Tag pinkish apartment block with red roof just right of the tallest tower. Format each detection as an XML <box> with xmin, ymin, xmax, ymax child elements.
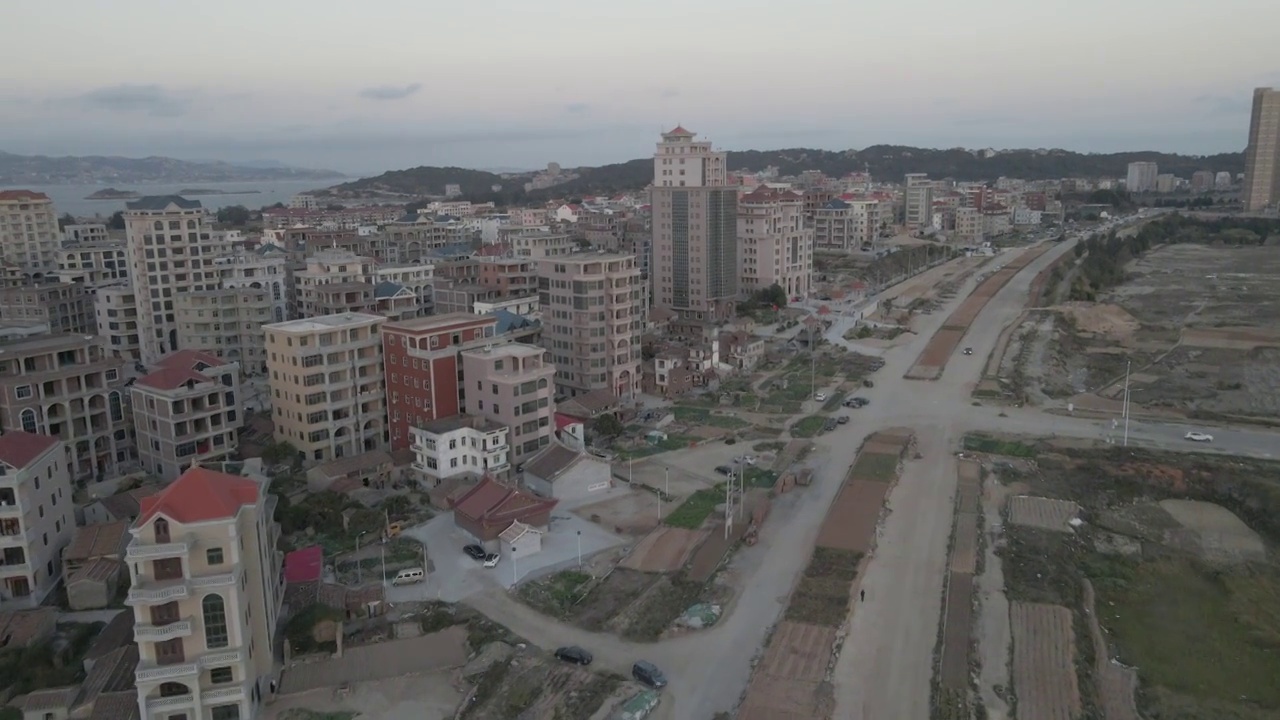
<box><xmin>737</xmin><ymin>187</ymin><xmax>813</xmax><ymax>297</ymax></box>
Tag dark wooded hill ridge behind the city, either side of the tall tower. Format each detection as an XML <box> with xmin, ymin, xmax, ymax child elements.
<box><xmin>330</xmin><ymin>145</ymin><xmax>1244</xmax><ymax>204</ymax></box>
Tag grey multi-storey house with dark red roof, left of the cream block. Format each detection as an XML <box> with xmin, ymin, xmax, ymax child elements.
<box><xmin>129</xmin><ymin>350</ymin><xmax>244</xmax><ymax>480</ymax></box>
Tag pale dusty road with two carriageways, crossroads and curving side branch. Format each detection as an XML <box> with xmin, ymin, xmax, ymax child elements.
<box><xmin>453</xmin><ymin>219</ymin><xmax>1280</xmax><ymax>720</ymax></box>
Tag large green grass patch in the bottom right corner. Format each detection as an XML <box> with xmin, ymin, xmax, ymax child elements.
<box><xmin>1097</xmin><ymin>559</ymin><xmax>1280</xmax><ymax>717</ymax></box>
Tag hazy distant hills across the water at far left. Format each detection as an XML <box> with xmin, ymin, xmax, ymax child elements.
<box><xmin>0</xmin><ymin>152</ymin><xmax>344</xmax><ymax>186</ymax></box>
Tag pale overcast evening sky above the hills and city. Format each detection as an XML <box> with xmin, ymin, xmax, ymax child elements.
<box><xmin>0</xmin><ymin>0</ymin><xmax>1280</xmax><ymax>174</ymax></box>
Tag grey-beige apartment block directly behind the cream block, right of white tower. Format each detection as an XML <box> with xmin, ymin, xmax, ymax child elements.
<box><xmin>174</xmin><ymin>287</ymin><xmax>277</xmax><ymax>375</ymax></box>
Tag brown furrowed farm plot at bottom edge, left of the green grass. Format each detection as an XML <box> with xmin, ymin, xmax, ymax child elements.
<box><xmin>1009</xmin><ymin>602</ymin><xmax>1080</xmax><ymax>720</ymax></box>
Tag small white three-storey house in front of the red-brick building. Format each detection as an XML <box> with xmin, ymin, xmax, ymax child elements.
<box><xmin>410</xmin><ymin>415</ymin><xmax>511</xmax><ymax>488</ymax></box>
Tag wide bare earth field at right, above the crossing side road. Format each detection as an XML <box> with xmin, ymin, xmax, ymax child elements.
<box><xmin>1001</xmin><ymin>243</ymin><xmax>1280</xmax><ymax>419</ymax></box>
